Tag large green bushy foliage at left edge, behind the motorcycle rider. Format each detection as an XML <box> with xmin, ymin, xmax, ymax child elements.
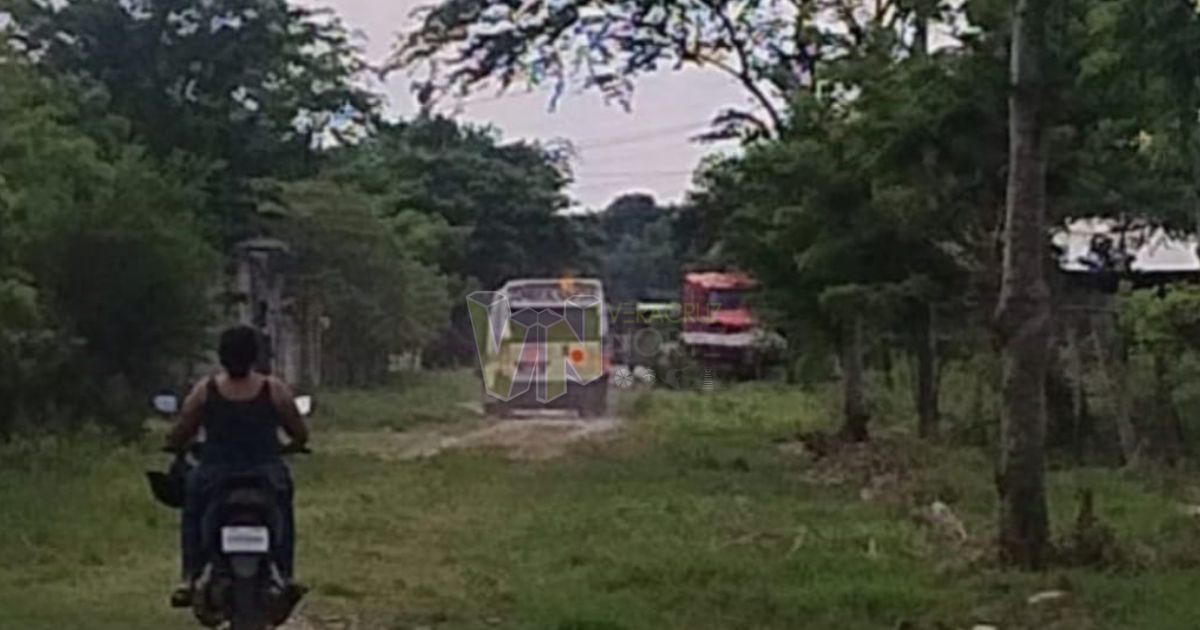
<box><xmin>0</xmin><ymin>54</ymin><xmax>214</xmax><ymax>432</ymax></box>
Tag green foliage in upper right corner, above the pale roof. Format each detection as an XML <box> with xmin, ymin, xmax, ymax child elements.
<box><xmin>1048</xmin><ymin>0</ymin><xmax>1200</xmax><ymax>228</ymax></box>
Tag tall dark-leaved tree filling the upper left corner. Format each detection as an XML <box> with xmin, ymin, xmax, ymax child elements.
<box><xmin>6</xmin><ymin>0</ymin><xmax>378</xmax><ymax>241</ymax></box>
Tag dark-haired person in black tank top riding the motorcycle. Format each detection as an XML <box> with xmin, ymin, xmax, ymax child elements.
<box><xmin>167</xmin><ymin>326</ymin><xmax>308</xmax><ymax>607</ymax></box>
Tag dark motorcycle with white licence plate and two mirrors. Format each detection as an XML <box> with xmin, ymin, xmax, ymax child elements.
<box><xmin>146</xmin><ymin>394</ymin><xmax>313</xmax><ymax>630</ymax></box>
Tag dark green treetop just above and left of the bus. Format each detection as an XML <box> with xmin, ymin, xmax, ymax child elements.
<box><xmin>332</xmin><ymin>118</ymin><xmax>577</xmax><ymax>289</ymax></box>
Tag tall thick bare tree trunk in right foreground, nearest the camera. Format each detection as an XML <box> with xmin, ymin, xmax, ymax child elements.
<box><xmin>996</xmin><ymin>0</ymin><xmax>1050</xmax><ymax>569</ymax></box>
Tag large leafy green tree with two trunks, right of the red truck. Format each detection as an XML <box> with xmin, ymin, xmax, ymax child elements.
<box><xmin>694</xmin><ymin>39</ymin><xmax>984</xmax><ymax>439</ymax></box>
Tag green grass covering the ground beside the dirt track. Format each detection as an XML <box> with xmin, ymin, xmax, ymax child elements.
<box><xmin>0</xmin><ymin>377</ymin><xmax>1200</xmax><ymax>630</ymax></box>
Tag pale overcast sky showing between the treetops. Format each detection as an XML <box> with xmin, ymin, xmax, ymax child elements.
<box><xmin>312</xmin><ymin>0</ymin><xmax>745</xmax><ymax>208</ymax></box>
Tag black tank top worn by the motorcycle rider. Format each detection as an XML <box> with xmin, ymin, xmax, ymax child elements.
<box><xmin>200</xmin><ymin>378</ymin><xmax>283</xmax><ymax>467</ymax></box>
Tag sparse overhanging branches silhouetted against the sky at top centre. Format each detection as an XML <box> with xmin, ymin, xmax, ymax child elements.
<box><xmin>394</xmin><ymin>0</ymin><xmax>950</xmax><ymax>137</ymax></box>
